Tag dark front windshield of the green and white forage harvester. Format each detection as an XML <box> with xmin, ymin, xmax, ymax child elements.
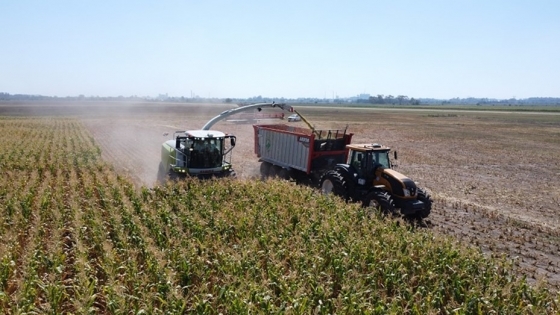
<box><xmin>187</xmin><ymin>138</ymin><xmax>224</xmax><ymax>168</ymax></box>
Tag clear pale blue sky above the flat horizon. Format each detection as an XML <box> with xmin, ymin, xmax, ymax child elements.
<box><xmin>0</xmin><ymin>0</ymin><xmax>560</xmax><ymax>98</ymax></box>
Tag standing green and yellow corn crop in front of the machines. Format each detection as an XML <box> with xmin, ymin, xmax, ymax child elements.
<box><xmin>0</xmin><ymin>117</ymin><xmax>559</xmax><ymax>314</ymax></box>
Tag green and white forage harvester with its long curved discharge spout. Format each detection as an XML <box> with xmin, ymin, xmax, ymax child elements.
<box><xmin>158</xmin><ymin>102</ymin><xmax>293</xmax><ymax>182</ymax></box>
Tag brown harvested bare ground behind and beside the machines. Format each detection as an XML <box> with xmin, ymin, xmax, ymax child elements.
<box><xmin>0</xmin><ymin>103</ymin><xmax>560</xmax><ymax>291</ymax></box>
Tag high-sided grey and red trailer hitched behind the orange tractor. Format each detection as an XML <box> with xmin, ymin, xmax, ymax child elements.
<box><xmin>253</xmin><ymin>124</ymin><xmax>353</xmax><ymax>183</ymax></box>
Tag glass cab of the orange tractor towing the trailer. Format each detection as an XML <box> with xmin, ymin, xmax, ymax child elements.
<box><xmin>346</xmin><ymin>143</ymin><xmax>396</xmax><ymax>185</ymax></box>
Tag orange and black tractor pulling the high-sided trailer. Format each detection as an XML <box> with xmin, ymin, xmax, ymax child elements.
<box><xmin>320</xmin><ymin>143</ymin><xmax>432</xmax><ymax>219</ymax></box>
